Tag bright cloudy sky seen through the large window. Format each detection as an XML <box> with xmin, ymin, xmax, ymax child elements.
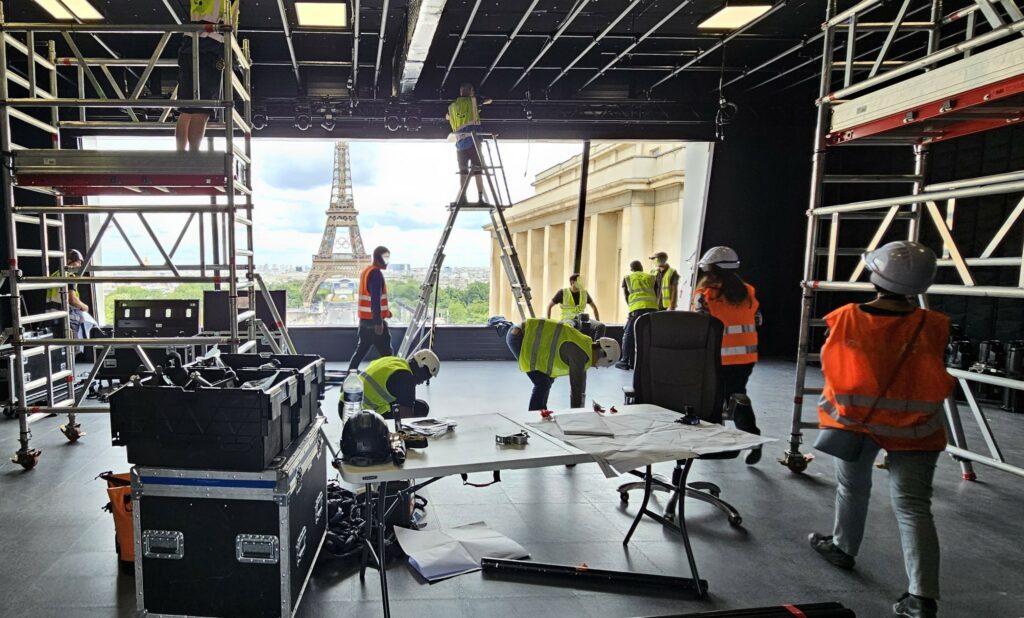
<box><xmin>86</xmin><ymin>138</ymin><xmax>582</xmax><ymax>266</ymax></box>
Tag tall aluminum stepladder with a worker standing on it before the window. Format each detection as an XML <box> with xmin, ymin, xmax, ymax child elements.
<box><xmin>398</xmin><ymin>133</ymin><xmax>535</xmax><ymax>358</ymax></box>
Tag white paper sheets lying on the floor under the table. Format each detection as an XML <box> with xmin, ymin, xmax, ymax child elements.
<box><xmin>394</xmin><ymin>522</ymin><xmax>529</xmax><ymax>581</ymax></box>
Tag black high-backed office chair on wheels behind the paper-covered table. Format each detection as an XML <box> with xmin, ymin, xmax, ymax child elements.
<box><xmin>618</xmin><ymin>311</ymin><xmax>743</xmax><ymax>527</ymax></box>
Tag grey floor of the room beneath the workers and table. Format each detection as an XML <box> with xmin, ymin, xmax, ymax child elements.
<box><xmin>0</xmin><ymin>362</ymin><xmax>1024</xmax><ymax>618</ymax></box>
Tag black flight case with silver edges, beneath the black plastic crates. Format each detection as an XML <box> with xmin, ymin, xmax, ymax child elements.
<box><xmin>131</xmin><ymin>420</ymin><xmax>327</xmax><ymax>618</ymax></box>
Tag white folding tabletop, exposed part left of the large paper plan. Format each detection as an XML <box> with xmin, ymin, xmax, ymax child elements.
<box><xmin>341</xmin><ymin>412</ymin><xmax>593</xmax><ymax>483</ymax></box>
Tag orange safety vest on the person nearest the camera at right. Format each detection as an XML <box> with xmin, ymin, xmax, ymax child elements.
<box><xmin>818</xmin><ymin>304</ymin><xmax>953</xmax><ymax>451</ymax></box>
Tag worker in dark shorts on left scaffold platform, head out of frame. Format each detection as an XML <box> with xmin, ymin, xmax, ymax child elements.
<box><xmin>174</xmin><ymin>0</ymin><xmax>239</xmax><ymax>152</ymax></box>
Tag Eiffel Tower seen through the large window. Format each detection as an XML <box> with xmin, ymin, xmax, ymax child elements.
<box><xmin>302</xmin><ymin>141</ymin><xmax>370</xmax><ymax>305</ymax></box>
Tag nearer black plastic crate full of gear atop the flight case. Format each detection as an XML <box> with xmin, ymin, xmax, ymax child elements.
<box><xmin>111</xmin><ymin>369</ymin><xmax>299</xmax><ymax>471</ymax></box>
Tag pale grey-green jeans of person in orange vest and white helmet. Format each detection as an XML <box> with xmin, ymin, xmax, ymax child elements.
<box><xmin>833</xmin><ymin>440</ymin><xmax>939</xmax><ymax>600</ymax></box>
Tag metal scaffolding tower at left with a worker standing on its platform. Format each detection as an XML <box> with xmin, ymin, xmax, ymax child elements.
<box><xmin>0</xmin><ymin>12</ymin><xmax>294</xmax><ymax>469</ymax></box>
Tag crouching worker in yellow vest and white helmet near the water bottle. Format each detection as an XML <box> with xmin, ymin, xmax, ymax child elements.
<box><xmin>354</xmin><ymin>350</ymin><xmax>441</xmax><ymax>418</ymax></box>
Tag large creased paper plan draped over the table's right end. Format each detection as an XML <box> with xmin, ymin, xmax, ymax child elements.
<box><xmin>527</xmin><ymin>410</ymin><xmax>774</xmax><ymax>479</ymax></box>
